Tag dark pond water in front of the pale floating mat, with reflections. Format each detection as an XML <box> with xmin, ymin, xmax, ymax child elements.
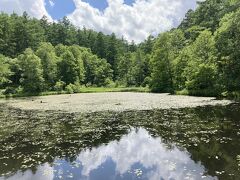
<box><xmin>0</xmin><ymin>104</ymin><xmax>240</xmax><ymax>180</ymax></box>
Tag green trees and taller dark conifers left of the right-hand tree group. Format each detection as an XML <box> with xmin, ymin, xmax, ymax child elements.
<box><xmin>0</xmin><ymin>13</ymin><xmax>150</xmax><ymax>94</ymax></box>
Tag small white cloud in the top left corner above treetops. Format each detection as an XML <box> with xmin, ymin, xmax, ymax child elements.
<box><xmin>0</xmin><ymin>0</ymin><xmax>52</xmax><ymax>20</ymax></box>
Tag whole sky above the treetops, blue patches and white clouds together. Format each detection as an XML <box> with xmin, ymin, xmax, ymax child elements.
<box><xmin>0</xmin><ymin>0</ymin><xmax>197</xmax><ymax>43</ymax></box>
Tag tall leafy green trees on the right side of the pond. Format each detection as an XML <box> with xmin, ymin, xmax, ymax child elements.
<box><xmin>150</xmin><ymin>0</ymin><xmax>240</xmax><ymax>95</ymax></box>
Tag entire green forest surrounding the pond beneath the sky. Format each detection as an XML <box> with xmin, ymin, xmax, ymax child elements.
<box><xmin>0</xmin><ymin>0</ymin><xmax>240</xmax><ymax>96</ymax></box>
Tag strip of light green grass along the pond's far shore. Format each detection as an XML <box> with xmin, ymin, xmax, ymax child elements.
<box><xmin>0</xmin><ymin>87</ymin><xmax>150</xmax><ymax>98</ymax></box>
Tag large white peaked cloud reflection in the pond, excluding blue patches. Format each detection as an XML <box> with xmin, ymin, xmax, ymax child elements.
<box><xmin>78</xmin><ymin>128</ymin><xmax>216</xmax><ymax>180</ymax></box>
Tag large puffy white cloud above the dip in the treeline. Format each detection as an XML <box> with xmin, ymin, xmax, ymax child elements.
<box><xmin>68</xmin><ymin>0</ymin><xmax>199</xmax><ymax>42</ymax></box>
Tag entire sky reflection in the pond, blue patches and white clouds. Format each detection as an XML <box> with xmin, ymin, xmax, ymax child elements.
<box><xmin>0</xmin><ymin>128</ymin><xmax>217</xmax><ymax>180</ymax></box>
